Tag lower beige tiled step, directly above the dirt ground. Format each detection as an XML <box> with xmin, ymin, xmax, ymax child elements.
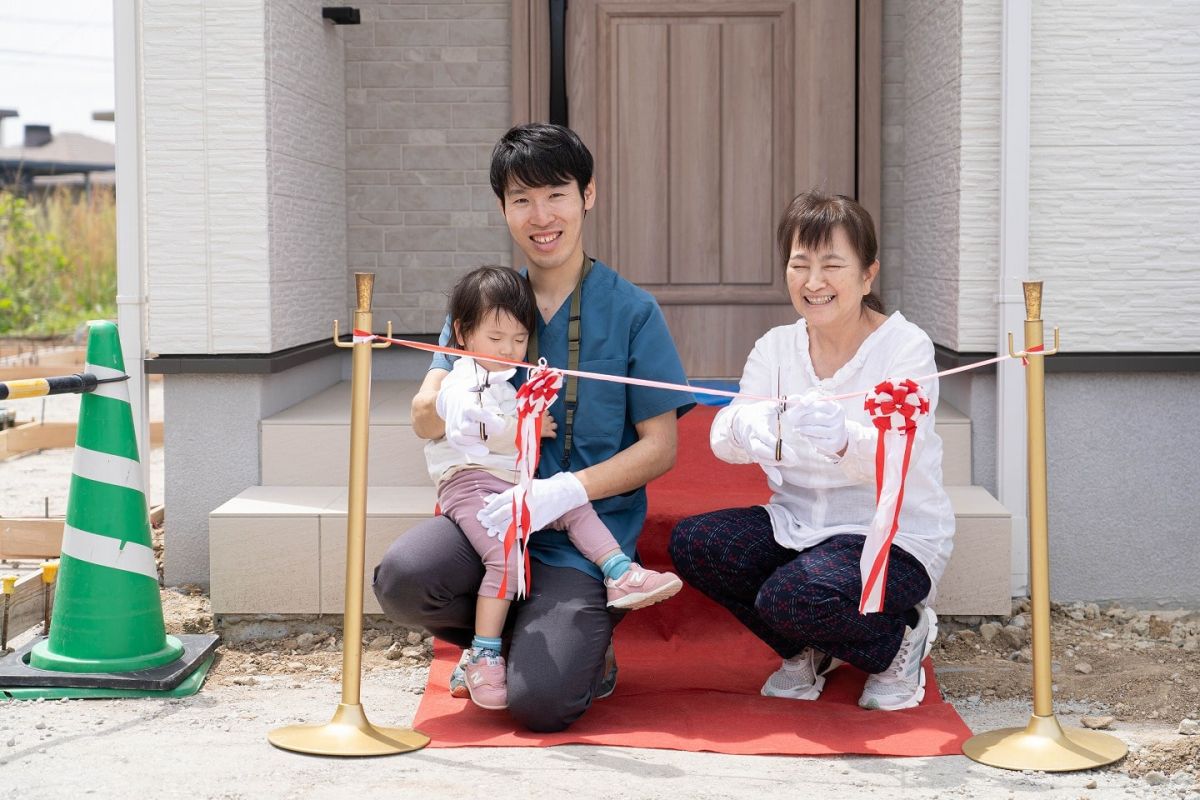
<box><xmin>209</xmin><ymin>486</ymin><xmax>1012</xmax><ymax>614</ymax></box>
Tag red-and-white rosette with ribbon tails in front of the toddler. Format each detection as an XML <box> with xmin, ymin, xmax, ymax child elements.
<box><xmin>496</xmin><ymin>359</ymin><xmax>563</xmax><ymax>599</ymax></box>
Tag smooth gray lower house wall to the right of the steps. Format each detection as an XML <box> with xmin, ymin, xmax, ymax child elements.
<box><xmin>942</xmin><ymin>365</ymin><xmax>1200</xmax><ymax>606</ymax></box>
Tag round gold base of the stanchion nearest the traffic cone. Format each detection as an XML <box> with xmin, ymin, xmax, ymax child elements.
<box><xmin>266</xmin><ymin>703</ymin><xmax>430</xmax><ymax>756</ymax></box>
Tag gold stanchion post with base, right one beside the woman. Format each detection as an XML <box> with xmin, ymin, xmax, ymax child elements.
<box><xmin>962</xmin><ymin>281</ymin><xmax>1128</xmax><ymax>772</ymax></box>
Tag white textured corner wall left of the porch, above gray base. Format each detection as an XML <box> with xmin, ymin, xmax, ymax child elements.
<box><xmin>142</xmin><ymin>0</ymin><xmax>346</xmax><ymax>354</ymax></box>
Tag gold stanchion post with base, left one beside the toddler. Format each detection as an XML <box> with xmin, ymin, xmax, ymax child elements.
<box><xmin>266</xmin><ymin>272</ymin><xmax>430</xmax><ymax>756</ymax></box>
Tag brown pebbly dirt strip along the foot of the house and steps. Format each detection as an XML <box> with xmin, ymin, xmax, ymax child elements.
<box><xmin>154</xmin><ymin>587</ymin><xmax>1200</xmax><ymax>781</ymax></box>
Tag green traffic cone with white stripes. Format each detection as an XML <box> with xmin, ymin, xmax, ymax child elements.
<box><xmin>29</xmin><ymin>321</ymin><xmax>184</xmax><ymax>673</ymax></box>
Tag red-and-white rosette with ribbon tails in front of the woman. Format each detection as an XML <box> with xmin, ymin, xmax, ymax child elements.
<box><xmin>858</xmin><ymin>379</ymin><xmax>929</xmax><ymax>614</ymax></box>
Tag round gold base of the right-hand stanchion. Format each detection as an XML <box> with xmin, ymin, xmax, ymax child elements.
<box><xmin>962</xmin><ymin>715</ymin><xmax>1129</xmax><ymax>772</ymax></box>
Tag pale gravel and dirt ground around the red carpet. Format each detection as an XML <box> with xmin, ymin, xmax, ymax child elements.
<box><xmin>0</xmin><ymin>383</ymin><xmax>1200</xmax><ymax>800</ymax></box>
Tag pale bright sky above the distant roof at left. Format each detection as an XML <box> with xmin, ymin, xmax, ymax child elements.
<box><xmin>0</xmin><ymin>0</ymin><xmax>116</xmax><ymax>146</ymax></box>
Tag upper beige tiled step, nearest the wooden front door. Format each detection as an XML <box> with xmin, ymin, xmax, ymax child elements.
<box><xmin>260</xmin><ymin>380</ymin><xmax>971</xmax><ymax>486</ymax></box>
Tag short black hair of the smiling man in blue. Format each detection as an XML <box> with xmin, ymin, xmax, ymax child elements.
<box><xmin>491</xmin><ymin>122</ymin><xmax>593</xmax><ymax>203</ymax></box>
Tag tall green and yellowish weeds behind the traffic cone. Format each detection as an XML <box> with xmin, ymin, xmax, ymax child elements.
<box><xmin>0</xmin><ymin>190</ymin><xmax>116</xmax><ymax>335</ymax></box>
